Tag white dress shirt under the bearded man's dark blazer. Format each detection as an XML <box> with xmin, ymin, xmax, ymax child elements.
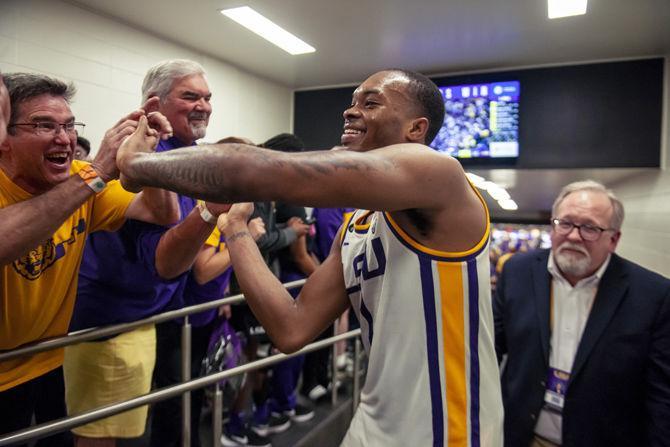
<box><xmin>535</xmin><ymin>252</ymin><xmax>610</xmax><ymax>445</ymax></box>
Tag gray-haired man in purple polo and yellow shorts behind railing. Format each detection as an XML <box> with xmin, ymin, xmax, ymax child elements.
<box><xmin>64</xmin><ymin>60</ymin><xmax>226</xmax><ymax>447</ymax></box>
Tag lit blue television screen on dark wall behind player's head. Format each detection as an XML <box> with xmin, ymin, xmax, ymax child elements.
<box><xmin>430</xmin><ymin>81</ymin><xmax>520</xmax><ymax>163</ymax></box>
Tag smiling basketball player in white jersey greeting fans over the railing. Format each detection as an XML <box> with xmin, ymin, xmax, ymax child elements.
<box><xmin>117</xmin><ymin>70</ymin><xmax>502</xmax><ymax>447</ymax></box>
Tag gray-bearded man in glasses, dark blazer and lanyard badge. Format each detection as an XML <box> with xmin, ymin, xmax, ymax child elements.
<box><xmin>493</xmin><ymin>180</ymin><xmax>670</xmax><ymax>447</ymax></box>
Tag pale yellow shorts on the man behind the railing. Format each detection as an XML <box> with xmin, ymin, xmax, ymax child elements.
<box><xmin>63</xmin><ymin>325</ymin><xmax>156</xmax><ymax>438</ymax></box>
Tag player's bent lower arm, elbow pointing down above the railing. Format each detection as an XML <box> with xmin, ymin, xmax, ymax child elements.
<box><xmin>220</xmin><ymin>203</ymin><xmax>349</xmax><ymax>353</ymax></box>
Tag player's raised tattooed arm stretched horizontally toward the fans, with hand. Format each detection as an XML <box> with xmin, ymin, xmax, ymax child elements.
<box><xmin>117</xmin><ymin>126</ymin><xmax>467</xmax><ymax>211</ymax></box>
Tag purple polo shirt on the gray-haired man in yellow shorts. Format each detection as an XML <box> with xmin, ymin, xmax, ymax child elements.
<box><xmin>70</xmin><ymin>137</ymin><xmax>196</xmax><ymax>331</ymax></box>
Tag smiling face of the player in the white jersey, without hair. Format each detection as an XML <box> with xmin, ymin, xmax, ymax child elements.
<box><xmin>340</xmin><ymin>71</ymin><xmax>415</xmax><ymax>151</ymax></box>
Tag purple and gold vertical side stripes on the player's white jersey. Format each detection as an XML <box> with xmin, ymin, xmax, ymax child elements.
<box><xmin>419</xmin><ymin>256</ymin><xmax>480</xmax><ymax>447</ymax></box>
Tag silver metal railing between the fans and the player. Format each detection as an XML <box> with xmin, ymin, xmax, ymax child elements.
<box><xmin>0</xmin><ymin>279</ymin><xmax>361</xmax><ymax>447</ymax></box>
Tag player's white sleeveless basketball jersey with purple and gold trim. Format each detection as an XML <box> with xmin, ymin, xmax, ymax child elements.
<box><xmin>342</xmin><ymin>210</ymin><xmax>503</xmax><ymax>447</ymax></box>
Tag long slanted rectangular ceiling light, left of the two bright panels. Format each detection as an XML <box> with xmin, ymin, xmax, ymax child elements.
<box><xmin>221</xmin><ymin>6</ymin><xmax>316</xmax><ymax>55</ymax></box>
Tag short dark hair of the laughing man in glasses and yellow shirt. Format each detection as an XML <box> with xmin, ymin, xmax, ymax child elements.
<box><xmin>2</xmin><ymin>73</ymin><xmax>77</xmax><ymax>126</ymax></box>
